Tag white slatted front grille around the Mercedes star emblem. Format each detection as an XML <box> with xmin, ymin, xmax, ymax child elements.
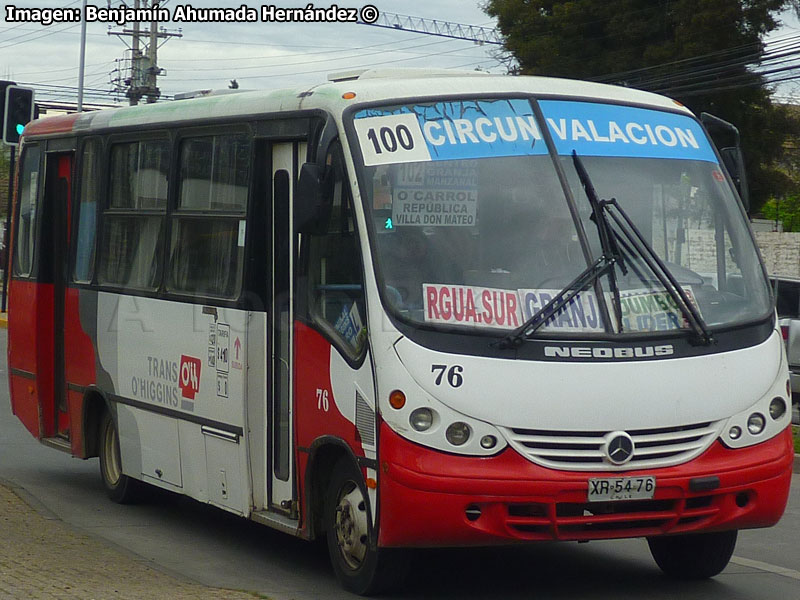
<box><xmin>503</xmin><ymin>421</ymin><xmax>723</xmax><ymax>471</ymax></box>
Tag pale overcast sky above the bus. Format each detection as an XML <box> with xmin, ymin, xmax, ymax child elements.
<box><xmin>0</xmin><ymin>0</ymin><xmax>800</xmax><ymax>102</ymax></box>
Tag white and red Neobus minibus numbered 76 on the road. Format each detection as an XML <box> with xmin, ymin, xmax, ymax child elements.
<box><xmin>8</xmin><ymin>71</ymin><xmax>792</xmax><ymax>593</ymax></box>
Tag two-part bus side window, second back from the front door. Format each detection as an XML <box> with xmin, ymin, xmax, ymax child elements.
<box><xmin>98</xmin><ymin>140</ymin><xmax>169</xmax><ymax>289</ymax></box>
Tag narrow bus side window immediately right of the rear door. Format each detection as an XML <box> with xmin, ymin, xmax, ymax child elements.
<box><xmin>72</xmin><ymin>139</ymin><xmax>102</xmax><ymax>283</ymax></box>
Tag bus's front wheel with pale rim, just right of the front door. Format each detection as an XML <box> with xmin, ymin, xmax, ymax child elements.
<box><xmin>325</xmin><ymin>458</ymin><xmax>408</xmax><ymax>596</ymax></box>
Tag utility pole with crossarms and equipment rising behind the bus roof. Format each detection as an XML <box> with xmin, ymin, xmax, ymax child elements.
<box><xmin>108</xmin><ymin>0</ymin><xmax>183</xmax><ymax>106</ymax></box>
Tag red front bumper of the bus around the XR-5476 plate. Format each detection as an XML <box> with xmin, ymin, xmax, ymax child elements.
<box><xmin>378</xmin><ymin>423</ymin><xmax>794</xmax><ymax>547</ymax></box>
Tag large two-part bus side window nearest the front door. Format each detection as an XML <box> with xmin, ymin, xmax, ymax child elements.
<box><xmin>167</xmin><ymin>134</ymin><xmax>250</xmax><ymax>298</ymax></box>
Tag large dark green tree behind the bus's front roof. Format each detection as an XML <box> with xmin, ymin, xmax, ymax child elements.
<box><xmin>484</xmin><ymin>0</ymin><xmax>800</xmax><ymax>211</ymax></box>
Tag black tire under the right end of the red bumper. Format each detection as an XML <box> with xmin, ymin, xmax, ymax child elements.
<box><xmin>647</xmin><ymin>529</ymin><xmax>738</xmax><ymax>579</ymax></box>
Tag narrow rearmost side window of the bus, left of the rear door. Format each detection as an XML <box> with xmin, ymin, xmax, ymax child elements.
<box><xmin>14</xmin><ymin>146</ymin><xmax>41</xmax><ymax>277</ymax></box>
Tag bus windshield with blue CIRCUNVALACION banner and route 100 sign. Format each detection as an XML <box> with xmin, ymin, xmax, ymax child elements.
<box><xmin>353</xmin><ymin>99</ymin><xmax>770</xmax><ymax>335</ymax></box>
